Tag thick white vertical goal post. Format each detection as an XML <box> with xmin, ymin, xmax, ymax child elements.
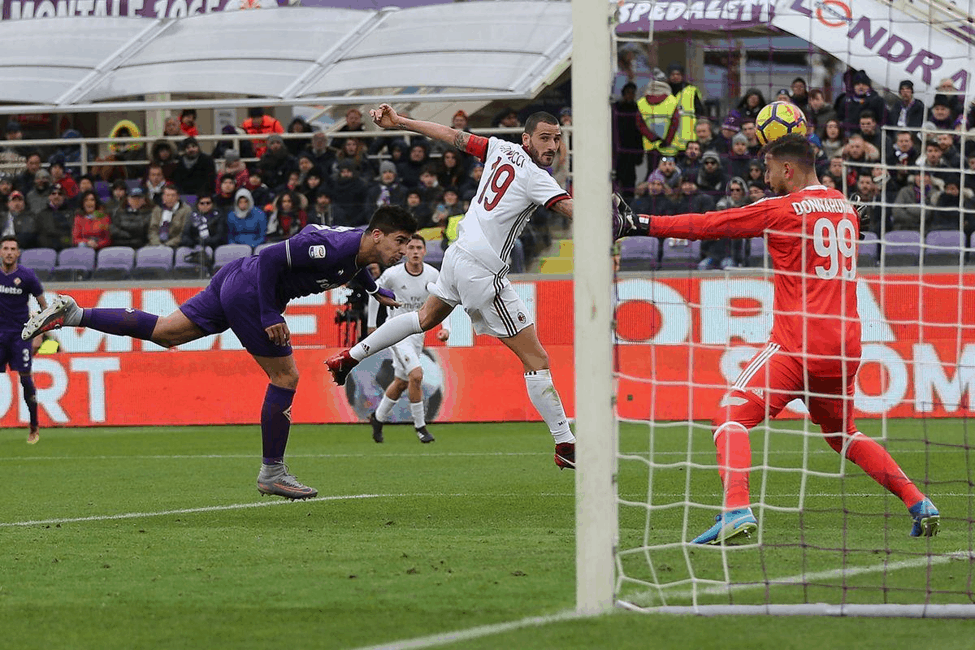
<box><xmin>572</xmin><ymin>0</ymin><xmax>619</xmax><ymax>614</ymax></box>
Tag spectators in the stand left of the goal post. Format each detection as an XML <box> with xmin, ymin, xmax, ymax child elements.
<box><xmin>0</xmin><ymin>108</ymin><xmax>570</xmax><ymax>272</ymax></box>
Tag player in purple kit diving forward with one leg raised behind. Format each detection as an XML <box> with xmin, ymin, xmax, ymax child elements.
<box><xmin>21</xmin><ymin>206</ymin><xmax>416</xmax><ymax>499</ymax></box>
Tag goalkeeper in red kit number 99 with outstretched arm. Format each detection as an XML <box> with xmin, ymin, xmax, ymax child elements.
<box><xmin>614</xmin><ymin>134</ymin><xmax>939</xmax><ymax>544</ymax></box>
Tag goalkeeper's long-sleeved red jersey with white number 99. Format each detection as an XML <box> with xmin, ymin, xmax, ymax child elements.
<box><xmin>649</xmin><ymin>185</ymin><xmax>860</xmax><ymax>377</ymax></box>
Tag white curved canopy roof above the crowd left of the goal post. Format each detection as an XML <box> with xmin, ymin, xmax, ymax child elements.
<box><xmin>0</xmin><ymin>1</ymin><xmax>572</xmax><ymax>114</ymax></box>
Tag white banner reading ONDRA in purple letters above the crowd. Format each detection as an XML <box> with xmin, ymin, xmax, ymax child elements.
<box><xmin>771</xmin><ymin>0</ymin><xmax>975</xmax><ymax>94</ymax></box>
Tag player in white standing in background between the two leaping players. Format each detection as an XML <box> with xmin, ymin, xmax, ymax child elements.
<box><xmin>368</xmin><ymin>235</ymin><xmax>450</xmax><ymax>442</ymax></box>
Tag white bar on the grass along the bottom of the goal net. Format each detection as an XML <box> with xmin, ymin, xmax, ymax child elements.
<box><xmin>617</xmin><ymin>601</ymin><xmax>975</xmax><ymax>618</ymax></box>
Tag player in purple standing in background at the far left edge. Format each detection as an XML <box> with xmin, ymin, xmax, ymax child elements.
<box><xmin>0</xmin><ymin>235</ymin><xmax>47</xmax><ymax>445</ymax></box>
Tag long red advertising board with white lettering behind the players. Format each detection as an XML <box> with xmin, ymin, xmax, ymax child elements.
<box><xmin>0</xmin><ymin>274</ymin><xmax>975</xmax><ymax>427</ymax></box>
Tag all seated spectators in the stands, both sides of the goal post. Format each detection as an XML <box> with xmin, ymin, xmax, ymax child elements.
<box><xmin>0</xmin><ymin>63</ymin><xmax>975</xmax><ymax>272</ymax></box>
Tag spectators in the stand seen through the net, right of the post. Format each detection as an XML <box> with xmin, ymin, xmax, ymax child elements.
<box><xmin>613</xmin><ymin>64</ymin><xmax>975</xmax><ymax>269</ymax></box>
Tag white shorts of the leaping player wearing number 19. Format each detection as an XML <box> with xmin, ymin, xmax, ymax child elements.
<box><xmin>430</xmin><ymin>246</ymin><xmax>534</xmax><ymax>338</ymax></box>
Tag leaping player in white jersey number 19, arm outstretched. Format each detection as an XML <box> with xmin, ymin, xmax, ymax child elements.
<box><xmin>326</xmin><ymin>104</ymin><xmax>575</xmax><ymax>469</ymax></box>
